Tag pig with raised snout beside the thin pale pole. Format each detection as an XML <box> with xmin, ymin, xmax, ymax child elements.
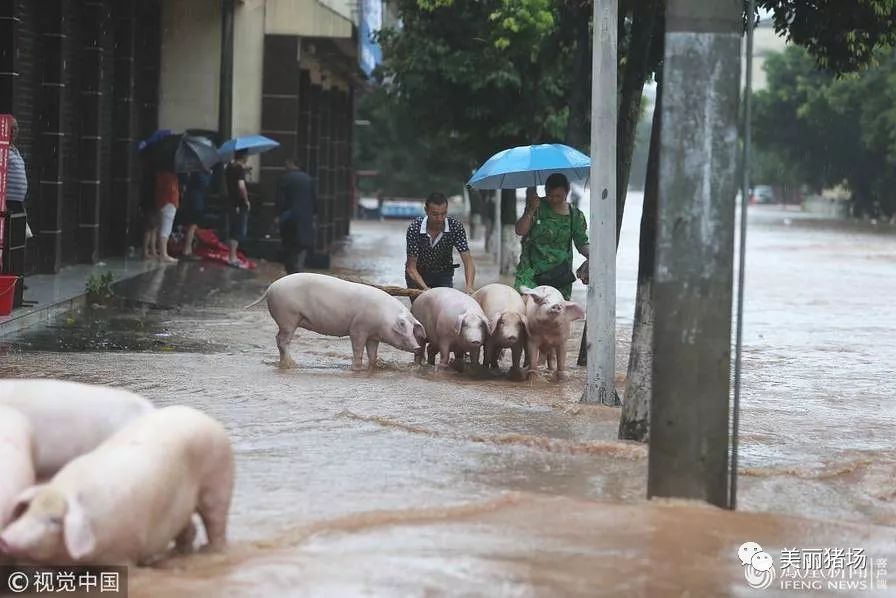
<box><xmin>520</xmin><ymin>286</ymin><xmax>585</xmax><ymax>379</ymax></box>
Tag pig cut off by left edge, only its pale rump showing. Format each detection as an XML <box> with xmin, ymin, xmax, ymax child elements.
<box><xmin>0</xmin><ymin>406</ymin><xmax>36</xmax><ymax>532</ymax></box>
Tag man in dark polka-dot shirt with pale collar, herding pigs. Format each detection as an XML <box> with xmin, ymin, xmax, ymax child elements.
<box><xmin>405</xmin><ymin>193</ymin><xmax>476</xmax><ymax>293</ymax></box>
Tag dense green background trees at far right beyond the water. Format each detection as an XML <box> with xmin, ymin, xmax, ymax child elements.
<box><xmin>753</xmin><ymin>46</ymin><xmax>896</xmax><ymax>214</ymax></box>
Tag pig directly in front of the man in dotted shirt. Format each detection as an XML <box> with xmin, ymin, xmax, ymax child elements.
<box><xmin>411</xmin><ymin>287</ymin><xmax>489</xmax><ymax>371</ymax></box>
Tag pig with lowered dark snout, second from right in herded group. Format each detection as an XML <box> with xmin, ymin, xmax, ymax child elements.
<box><xmin>473</xmin><ymin>283</ymin><xmax>526</xmax><ymax>373</ymax></box>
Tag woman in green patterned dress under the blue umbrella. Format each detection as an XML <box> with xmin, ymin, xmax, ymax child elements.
<box><xmin>513</xmin><ymin>173</ymin><xmax>588</xmax><ymax>301</ymax></box>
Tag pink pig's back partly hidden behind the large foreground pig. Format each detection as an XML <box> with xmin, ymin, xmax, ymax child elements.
<box><xmin>0</xmin><ymin>379</ymin><xmax>154</xmax><ymax>479</ymax></box>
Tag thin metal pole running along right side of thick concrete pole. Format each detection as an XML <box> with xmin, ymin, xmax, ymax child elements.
<box><xmin>728</xmin><ymin>0</ymin><xmax>756</xmax><ymax>509</ymax></box>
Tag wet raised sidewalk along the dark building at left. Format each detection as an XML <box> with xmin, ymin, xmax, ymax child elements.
<box><xmin>0</xmin><ymin>258</ymin><xmax>165</xmax><ymax>337</ymax></box>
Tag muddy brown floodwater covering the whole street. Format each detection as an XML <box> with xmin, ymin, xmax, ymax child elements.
<box><xmin>0</xmin><ymin>194</ymin><xmax>896</xmax><ymax>596</ymax></box>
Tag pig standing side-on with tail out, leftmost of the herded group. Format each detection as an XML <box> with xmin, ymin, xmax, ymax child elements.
<box><xmin>246</xmin><ymin>273</ymin><xmax>426</xmax><ymax>370</ymax></box>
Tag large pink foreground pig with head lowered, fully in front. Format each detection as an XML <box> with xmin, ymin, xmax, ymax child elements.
<box><xmin>0</xmin><ymin>406</ymin><xmax>233</xmax><ymax>565</ymax></box>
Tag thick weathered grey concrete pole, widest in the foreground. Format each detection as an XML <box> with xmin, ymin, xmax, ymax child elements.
<box><xmin>647</xmin><ymin>0</ymin><xmax>743</xmax><ymax>507</ymax></box>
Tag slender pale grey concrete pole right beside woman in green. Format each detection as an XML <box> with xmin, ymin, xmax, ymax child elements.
<box><xmin>582</xmin><ymin>0</ymin><xmax>619</xmax><ymax>405</ymax></box>
